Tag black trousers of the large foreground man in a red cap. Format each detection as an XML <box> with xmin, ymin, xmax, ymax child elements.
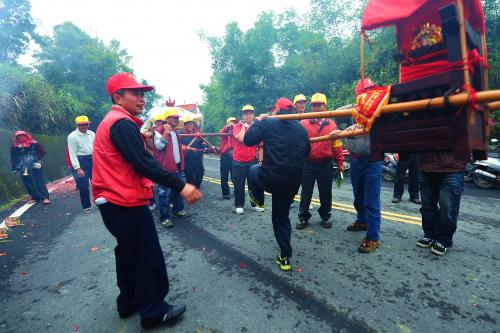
<box><xmin>98</xmin><ymin>202</ymin><xmax>169</xmax><ymax>318</ymax></box>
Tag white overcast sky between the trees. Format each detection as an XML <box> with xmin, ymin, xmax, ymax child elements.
<box><xmin>31</xmin><ymin>0</ymin><xmax>310</xmax><ymax>104</ymax></box>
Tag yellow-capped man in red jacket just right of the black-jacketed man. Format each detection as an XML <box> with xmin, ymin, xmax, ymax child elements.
<box><xmin>296</xmin><ymin>93</ymin><xmax>344</xmax><ymax>229</ymax></box>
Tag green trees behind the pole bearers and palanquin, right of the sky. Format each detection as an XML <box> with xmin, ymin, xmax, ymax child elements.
<box><xmin>200</xmin><ymin>0</ymin><xmax>500</xmax><ymax>137</ymax></box>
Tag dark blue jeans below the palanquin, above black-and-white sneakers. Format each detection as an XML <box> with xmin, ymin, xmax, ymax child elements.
<box><xmin>418</xmin><ymin>172</ymin><xmax>464</xmax><ymax>247</ymax></box>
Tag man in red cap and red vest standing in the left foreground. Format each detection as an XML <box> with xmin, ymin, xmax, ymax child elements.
<box><xmin>92</xmin><ymin>73</ymin><xmax>202</xmax><ymax>328</ymax></box>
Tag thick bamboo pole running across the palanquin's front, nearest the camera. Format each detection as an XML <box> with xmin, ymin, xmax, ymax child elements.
<box><xmin>269</xmin><ymin>89</ymin><xmax>500</xmax><ymax>120</ymax></box>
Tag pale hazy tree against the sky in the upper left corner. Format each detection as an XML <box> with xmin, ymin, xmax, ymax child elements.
<box><xmin>0</xmin><ymin>0</ymin><xmax>38</xmax><ymax>63</ymax></box>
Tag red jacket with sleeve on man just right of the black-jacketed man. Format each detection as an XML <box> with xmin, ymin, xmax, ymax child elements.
<box><xmin>300</xmin><ymin>118</ymin><xmax>344</xmax><ymax>168</ymax></box>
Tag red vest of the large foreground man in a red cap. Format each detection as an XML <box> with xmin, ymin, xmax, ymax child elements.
<box><xmin>92</xmin><ymin>105</ymin><xmax>153</xmax><ymax>207</ymax></box>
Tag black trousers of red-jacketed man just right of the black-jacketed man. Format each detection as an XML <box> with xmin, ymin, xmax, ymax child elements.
<box><xmin>299</xmin><ymin>159</ymin><xmax>333</xmax><ymax>221</ymax></box>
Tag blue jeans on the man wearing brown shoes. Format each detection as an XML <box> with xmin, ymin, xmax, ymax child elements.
<box><xmin>349</xmin><ymin>157</ymin><xmax>382</xmax><ymax>240</ymax></box>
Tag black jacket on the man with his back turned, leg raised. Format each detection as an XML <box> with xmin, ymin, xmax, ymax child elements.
<box><xmin>243</xmin><ymin>118</ymin><xmax>311</xmax><ymax>193</ymax></box>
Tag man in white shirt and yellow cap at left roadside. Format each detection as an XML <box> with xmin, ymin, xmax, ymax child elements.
<box><xmin>68</xmin><ymin>116</ymin><xmax>95</xmax><ymax>212</ymax></box>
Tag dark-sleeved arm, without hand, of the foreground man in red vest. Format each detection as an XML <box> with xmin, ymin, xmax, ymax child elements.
<box><xmin>110</xmin><ymin>119</ymin><xmax>185</xmax><ymax>192</ymax></box>
